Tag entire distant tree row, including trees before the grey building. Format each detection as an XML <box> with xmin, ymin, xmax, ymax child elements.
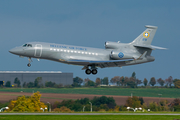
<box><xmin>2</xmin><ymin>72</ymin><xmax>180</xmax><ymax>88</ymax></box>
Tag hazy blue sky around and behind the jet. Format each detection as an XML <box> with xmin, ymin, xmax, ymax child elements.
<box><xmin>0</xmin><ymin>0</ymin><xmax>180</xmax><ymax>80</ymax></box>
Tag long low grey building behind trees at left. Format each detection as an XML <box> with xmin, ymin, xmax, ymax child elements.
<box><xmin>0</xmin><ymin>71</ymin><xmax>73</xmax><ymax>86</ymax></box>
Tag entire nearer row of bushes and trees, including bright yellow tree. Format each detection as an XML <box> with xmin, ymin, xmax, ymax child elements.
<box><xmin>0</xmin><ymin>92</ymin><xmax>180</xmax><ymax>112</ymax></box>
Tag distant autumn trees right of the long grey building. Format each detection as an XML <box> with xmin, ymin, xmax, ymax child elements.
<box><xmin>72</xmin><ymin>72</ymin><xmax>180</xmax><ymax>88</ymax></box>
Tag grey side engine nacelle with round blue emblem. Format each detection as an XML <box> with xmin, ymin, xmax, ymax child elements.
<box><xmin>110</xmin><ymin>50</ymin><xmax>134</xmax><ymax>60</ymax></box>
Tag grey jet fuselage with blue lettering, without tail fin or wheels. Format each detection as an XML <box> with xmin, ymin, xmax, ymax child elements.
<box><xmin>9</xmin><ymin>42</ymin><xmax>155</xmax><ymax>68</ymax></box>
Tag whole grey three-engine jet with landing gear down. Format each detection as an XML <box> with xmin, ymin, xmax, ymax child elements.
<box><xmin>9</xmin><ymin>25</ymin><xmax>166</xmax><ymax>74</ymax></box>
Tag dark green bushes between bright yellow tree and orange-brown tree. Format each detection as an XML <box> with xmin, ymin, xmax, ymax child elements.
<box><xmin>52</xmin><ymin>96</ymin><xmax>117</xmax><ymax>112</ymax></box>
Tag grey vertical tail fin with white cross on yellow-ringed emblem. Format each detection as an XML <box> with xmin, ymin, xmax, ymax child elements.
<box><xmin>130</xmin><ymin>25</ymin><xmax>158</xmax><ymax>46</ymax></box>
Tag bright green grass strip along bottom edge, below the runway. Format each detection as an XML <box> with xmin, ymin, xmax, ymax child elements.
<box><xmin>0</xmin><ymin>115</ymin><xmax>180</xmax><ymax>120</ymax></box>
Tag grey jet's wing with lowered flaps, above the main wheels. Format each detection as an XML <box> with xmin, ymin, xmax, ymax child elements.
<box><xmin>68</xmin><ymin>59</ymin><xmax>134</xmax><ymax>68</ymax></box>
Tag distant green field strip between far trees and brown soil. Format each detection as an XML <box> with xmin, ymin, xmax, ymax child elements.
<box><xmin>0</xmin><ymin>88</ymin><xmax>180</xmax><ymax>98</ymax></box>
